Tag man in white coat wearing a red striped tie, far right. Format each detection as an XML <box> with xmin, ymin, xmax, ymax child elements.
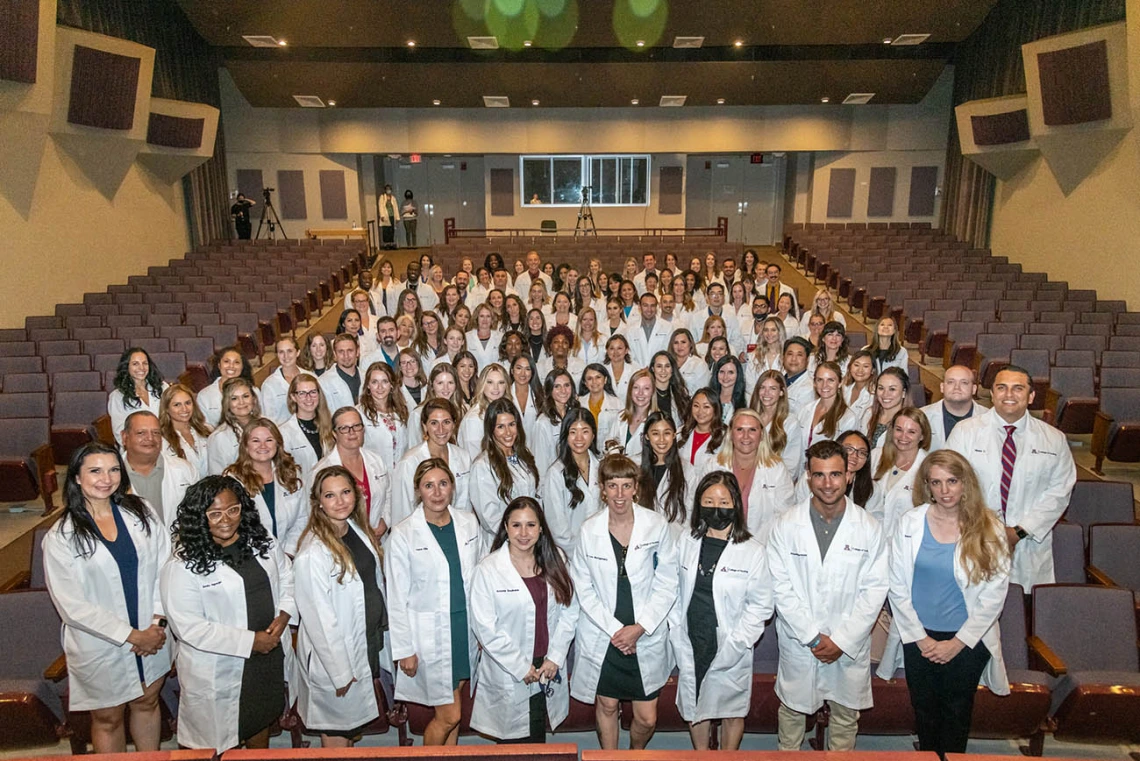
<box><xmin>946</xmin><ymin>365</ymin><xmax>1076</xmax><ymax>595</ymax></box>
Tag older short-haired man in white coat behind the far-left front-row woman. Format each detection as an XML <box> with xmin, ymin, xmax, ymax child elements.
<box><xmin>123</xmin><ymin>410</ymin><xmax>198</xmax><ymax>531</ymax></box>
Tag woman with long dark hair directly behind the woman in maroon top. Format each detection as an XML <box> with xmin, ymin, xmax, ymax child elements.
<box><xmin>470</xmin><ymin>399</ymin><xmax>538</xmax><ymax>545</ymax></box>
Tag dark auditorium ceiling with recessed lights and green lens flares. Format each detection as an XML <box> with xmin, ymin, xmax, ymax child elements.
<box><xmin>179</xmin><ymin>0</ymin><xmax>995</xmax><ymax>108</ymax></box>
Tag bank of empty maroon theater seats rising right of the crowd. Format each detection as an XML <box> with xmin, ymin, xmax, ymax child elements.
<box><xmin>784</xmin><ymin>226</ymin><xmax>1140</xmax><ymax>472</ymax></box>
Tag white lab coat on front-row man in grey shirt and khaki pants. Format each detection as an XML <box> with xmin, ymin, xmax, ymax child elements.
<box><xmin>767</xmin><ymin>498</ymin><xmax>888</xmax><ymax>713</ymax></box>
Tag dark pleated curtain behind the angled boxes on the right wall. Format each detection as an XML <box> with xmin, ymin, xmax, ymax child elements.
<box><xmin>942</xmin><ymin>0</ymin><xmax>1125</xmax><ymax>248</ymax></box>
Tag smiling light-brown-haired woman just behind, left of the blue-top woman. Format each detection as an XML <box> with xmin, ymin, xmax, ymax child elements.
<box><xmin>863</xmin><ymin>407</ymin><xmax>930</xmax><ymax>538</ymax></box>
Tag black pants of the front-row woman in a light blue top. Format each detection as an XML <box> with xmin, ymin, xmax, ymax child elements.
<box><xmin>903</xmin><ymin>630</ymin><xmax>990</xmax><ymax>755</ymax></box>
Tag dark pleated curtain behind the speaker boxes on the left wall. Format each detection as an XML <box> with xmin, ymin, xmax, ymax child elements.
<box><xmin>56</xmin><ymin>0</ymin><xmax>231</xmax><ymax>245</ymax></box>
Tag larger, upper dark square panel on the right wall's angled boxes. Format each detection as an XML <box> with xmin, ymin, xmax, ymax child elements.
<box><xmin>1037</xmin><ymin>40</ymin><xmax>1113</xmax><ymax>126</ymax></box>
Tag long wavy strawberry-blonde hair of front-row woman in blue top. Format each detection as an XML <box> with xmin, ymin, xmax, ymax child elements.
<box><xmin>913</xmin><ymin>449</ymin><xmax>1010</xmax><ymax>584</ymax></box>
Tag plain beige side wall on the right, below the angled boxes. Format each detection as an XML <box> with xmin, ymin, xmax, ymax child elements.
<box><xmin>990</xmin><ymin>0</ymin><xmax>1140</xmax><ymax>309</ymax></box>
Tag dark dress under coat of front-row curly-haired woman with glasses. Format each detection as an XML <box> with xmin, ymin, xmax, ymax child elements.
<box><xmin>221</xmin><ymin>543</ymin><xmax>287</xmax><ymax>743</ymax></box>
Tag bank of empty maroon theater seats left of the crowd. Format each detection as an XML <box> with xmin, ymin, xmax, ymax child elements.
<box><xmin>0</xmin><ymin>240</ymin><xmax>367</xmax><ymax>509</ymax></box>
